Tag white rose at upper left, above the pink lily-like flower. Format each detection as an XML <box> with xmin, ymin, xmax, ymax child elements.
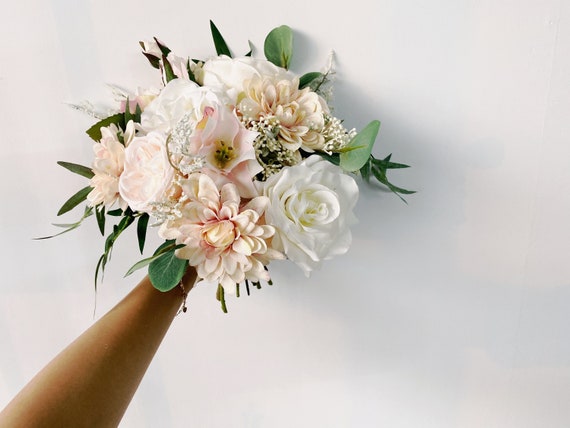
<box><xmin>141</xmin><ymin>79</ymin><xmax>221</xmax><ymax>133</ymax></box>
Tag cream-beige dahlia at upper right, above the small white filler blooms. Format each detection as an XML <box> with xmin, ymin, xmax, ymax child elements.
<box><xmin>237</xmin><ymin>76</ymin><xmax>328</xmax><ymax>152</ymax></box>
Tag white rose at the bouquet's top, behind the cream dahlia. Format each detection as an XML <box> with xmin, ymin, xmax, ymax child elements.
<box><xmin>196</xmin><ymin>55</ymin><xmax>295</xmax><ymax>103</ymax></box>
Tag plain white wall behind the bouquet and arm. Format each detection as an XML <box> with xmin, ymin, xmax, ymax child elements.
<box><xmin>0</xmin><ymin>0</ymin><xmax>570</xmax><ymax>428</ymax></box>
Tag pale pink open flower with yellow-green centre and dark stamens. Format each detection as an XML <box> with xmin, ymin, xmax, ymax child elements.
<box><xmin>190</xmin><ymin>105</ymin><xmax>262</xmax><ymax>198</ymax></box>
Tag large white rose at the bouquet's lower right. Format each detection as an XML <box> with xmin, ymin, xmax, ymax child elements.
<box><xmin>262</xmin><ymin>155</ymin><xmax>358</xmax><ymax>276</ymax></box>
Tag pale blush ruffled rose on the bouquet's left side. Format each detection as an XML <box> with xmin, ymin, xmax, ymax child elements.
<box><xmin>119</xmin><ymin>132</ymin><xmax>174</xmax><ymax>212</ymax></box>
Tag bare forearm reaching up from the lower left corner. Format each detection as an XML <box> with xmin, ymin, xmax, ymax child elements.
<box><xmin>0</xmin><ymin>268</ymin><xmax>196</xmax><ymax>428</ymax></box>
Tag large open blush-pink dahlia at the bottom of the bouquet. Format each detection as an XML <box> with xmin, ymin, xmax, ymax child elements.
<box><xmin>159</xmin><ymin>173</ymin><xmax>283</xmax><ymax>292</ymax></box>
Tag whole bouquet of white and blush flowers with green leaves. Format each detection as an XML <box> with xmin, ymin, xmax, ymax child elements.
<box><xmin>43</xmin><ymin>21</ymin><xmax>413</xmax><ymax>312</ymax></box>
